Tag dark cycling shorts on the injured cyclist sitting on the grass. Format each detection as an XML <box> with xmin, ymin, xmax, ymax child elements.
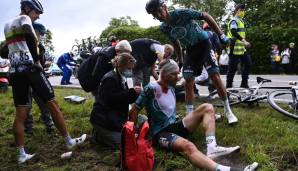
<box><xmin>153</xmin><ymin>121</ymin><xmax>189</xmax><ymax>151</ymax></box>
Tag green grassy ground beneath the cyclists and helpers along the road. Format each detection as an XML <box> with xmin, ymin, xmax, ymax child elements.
<box><xmin>0</xmin><ymin>89</ymin><xmax>298</xmax><ymax>171</ymax></box>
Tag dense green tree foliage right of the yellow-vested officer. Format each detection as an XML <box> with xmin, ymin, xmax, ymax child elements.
<box><xmin>235</xmin><ymin>0</ymin><xmax>298</xmax><ymax>73</ymax></box>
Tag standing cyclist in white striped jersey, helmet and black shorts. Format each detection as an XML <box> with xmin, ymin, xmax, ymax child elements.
<box><xmin>4</xmin><ymin>0</ymin><xmax>86</xmax><ymax>163</ymax></box>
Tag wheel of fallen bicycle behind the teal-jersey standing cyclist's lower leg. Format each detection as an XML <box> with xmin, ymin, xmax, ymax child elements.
<box><xmin>207</xmin><ymin>88</ymin><xmax>252</xmax><ymax>107</ymax></box>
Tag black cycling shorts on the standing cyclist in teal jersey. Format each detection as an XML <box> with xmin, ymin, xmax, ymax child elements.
<box><xmin>182</xmin><ymin>39</ymin><xmax>219</xmax><ymax>79</ymax></box>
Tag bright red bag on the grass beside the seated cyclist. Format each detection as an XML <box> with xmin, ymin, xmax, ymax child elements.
<box><xmin>121</xmin><ymin>121</ymin><xmax>154</xmax><ymax>171</ymax></box>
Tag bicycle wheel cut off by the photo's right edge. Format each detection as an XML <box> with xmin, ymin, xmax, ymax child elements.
<box><xmin>268</xmin><ymin>90</ymin><xmax>298</xmax><ymax>119</ymax></box>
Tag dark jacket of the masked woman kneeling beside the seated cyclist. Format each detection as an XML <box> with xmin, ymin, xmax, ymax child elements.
<box><xmin>90</xmin><ymin>69</ymin><xmax>138</xmax><ymax>132</ymax></box>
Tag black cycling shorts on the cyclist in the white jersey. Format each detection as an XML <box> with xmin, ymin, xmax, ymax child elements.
<box><xmin>10</xmin><ymin>71</ymin><xmax>55</xmax><ymax>106</ymax></box>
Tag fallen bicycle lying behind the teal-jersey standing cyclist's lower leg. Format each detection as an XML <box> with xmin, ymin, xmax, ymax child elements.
<box><xmin>207</xmin><ymin>77</ymin><xmax>275</xmax><ymax>107</ymax></box>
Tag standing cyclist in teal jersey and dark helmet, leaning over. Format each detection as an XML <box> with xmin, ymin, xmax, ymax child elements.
<box><xmin>146</xmin><ymin>0</ymin><xmax>238</xmax><ymax>124</ymax></box>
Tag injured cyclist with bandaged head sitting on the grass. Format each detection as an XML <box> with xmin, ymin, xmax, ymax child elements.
<box><xmin>129</xmin><ymin>60</ymin><xmax>258</xmax><ymax>171</ymax></box>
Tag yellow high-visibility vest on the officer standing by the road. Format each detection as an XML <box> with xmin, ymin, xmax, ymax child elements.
<box><xmin>228</xmin><ymin>17</ymin><xmax>246</xmax><ymax>55</ymax></box>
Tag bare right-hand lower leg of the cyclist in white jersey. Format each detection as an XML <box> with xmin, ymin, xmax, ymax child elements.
<box><xmin>47</xmin><ymin>100</ymin><xmax>68</xmax><ymax>137</ymax></box>
